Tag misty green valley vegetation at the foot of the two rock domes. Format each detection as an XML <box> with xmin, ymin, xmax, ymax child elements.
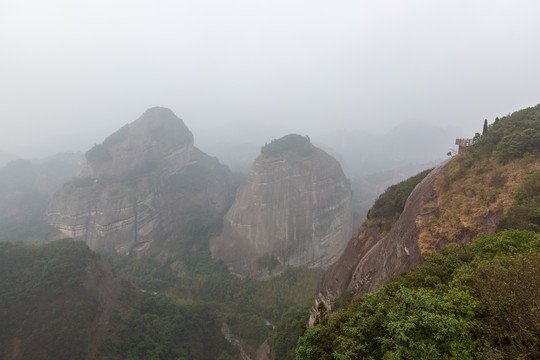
<box><xmin>103</xmin><ymin>214</ymin><xmax>322</xmax><ymax>354</ymax></box>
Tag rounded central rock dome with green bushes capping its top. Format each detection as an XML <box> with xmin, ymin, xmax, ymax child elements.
<box><xmin>211</xmin><ymin>135</ymin><xmax>353</xmax><ymax>278</ymax></box>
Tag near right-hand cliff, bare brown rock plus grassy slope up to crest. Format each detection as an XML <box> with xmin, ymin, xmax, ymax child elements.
<box><xmin>310</xmin><ymin>106</ymin><xmax>540</xmax><ymax>323</ymax></box>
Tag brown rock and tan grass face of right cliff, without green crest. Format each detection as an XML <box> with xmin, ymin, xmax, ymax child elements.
<box><xmin>310</xmin><ymin>151</ymin><xmax>540</xmax><ymax>323</ymax></box>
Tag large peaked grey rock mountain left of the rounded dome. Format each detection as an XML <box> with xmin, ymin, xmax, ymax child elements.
<box><xmin>46</xmin><ymin>108</ymin><xmax>232</xmax><ymax>255</ymax></box>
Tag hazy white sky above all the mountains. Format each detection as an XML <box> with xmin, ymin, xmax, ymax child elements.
<box><xmin>0</xmin><ymin>0</ymin><xmax>540</xmax><ymax>156</ymax></box>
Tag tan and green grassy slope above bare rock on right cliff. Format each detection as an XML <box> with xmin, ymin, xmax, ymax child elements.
<box><xmin>416</xmin><ymin>106</ymin><xmax>540</xmax><ymax>254</ymax></box>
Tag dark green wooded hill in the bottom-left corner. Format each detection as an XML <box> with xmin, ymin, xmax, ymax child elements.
<box><xmin>0</xmin><ymin>240</ymin><xmax>98</xmax><ymax>359</ymax></box>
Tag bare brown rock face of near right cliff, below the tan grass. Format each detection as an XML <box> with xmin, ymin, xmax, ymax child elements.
<box><xmin>310</xmin><ymin>165</ymin><xmax>445</xmax><ymax>324</ymax></box>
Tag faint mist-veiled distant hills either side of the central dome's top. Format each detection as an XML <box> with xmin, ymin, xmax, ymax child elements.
<box><xmin>190</xmin><ymin>121</ymin><xmax>456</xmax><ymax>178</ymax></box>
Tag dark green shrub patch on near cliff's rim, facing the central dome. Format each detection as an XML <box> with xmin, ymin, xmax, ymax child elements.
<box><xmin>367</xmin><ymin>169</ymin><xmax>433</xmax><ymax>223</ymax></box>
